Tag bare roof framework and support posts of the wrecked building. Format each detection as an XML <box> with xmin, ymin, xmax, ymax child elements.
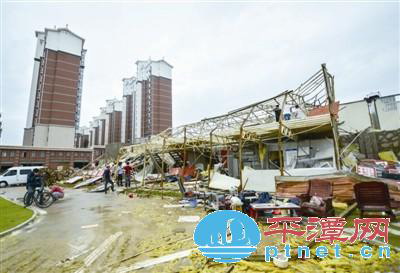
<box><xmin>121</xmin><ymin>64</ymin><xmax>340</xmax><ymax>189</ymax></box>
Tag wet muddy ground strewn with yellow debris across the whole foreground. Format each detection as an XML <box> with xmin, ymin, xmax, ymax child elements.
<box><xmin>0</xmin><ymin>188</ymin><xmax>400</xmax><ymax>273</ymax></box>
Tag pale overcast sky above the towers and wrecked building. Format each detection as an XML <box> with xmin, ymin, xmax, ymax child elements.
<box><xmin>0</xmin><ymin>1</ymin><xmax>400</xmax><ymax>145</ymax></box>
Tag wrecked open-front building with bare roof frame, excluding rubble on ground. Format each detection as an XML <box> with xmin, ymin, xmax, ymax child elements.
<box><xmin>120</xmin><ymin>64</ymin><xmax>340</xmax><ymax>191</ymax></box>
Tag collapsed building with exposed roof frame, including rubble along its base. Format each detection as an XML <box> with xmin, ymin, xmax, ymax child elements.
<box><xmin>69</xmin><ymin>64</ymin><xmax>400</xmax><ymax>202</ymax></box>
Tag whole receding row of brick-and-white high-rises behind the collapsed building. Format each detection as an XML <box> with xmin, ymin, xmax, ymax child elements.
<box><xmin>89</xmin><ymin>60</ymin><xmax>172</xmax><ymax>147</ymax></box>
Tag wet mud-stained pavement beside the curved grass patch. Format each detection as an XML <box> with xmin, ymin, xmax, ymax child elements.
<box><xmin>0</xmin><ymin>187</ymin><xmax>201</xmax><ymax>272</ymax></box>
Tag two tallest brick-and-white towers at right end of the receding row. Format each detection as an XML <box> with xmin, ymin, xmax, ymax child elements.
<box><xmin>121</xmin><ymin>60</ymin><xmax>172</xmax><ymax>143</ymax></box>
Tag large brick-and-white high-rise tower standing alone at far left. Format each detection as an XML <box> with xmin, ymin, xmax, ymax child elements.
<box><xmin>23</xmin><ymin>28</ymin><xmax>86</xmax><ymax>148</ymax></box>
